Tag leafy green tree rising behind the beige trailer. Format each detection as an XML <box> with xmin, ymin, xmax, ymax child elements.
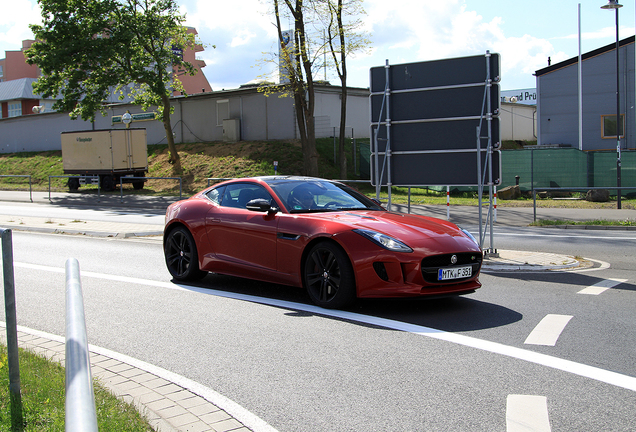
<box><xmin>27</xmin><ymin>0</ymin><xmax>196</xmax><ymax>172</ymax></box>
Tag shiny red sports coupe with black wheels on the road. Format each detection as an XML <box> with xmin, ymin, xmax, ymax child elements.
<box><xmin>163</xmin><ymin>176</ymin><xmax>483</xmax><ymax>308</ymax></box>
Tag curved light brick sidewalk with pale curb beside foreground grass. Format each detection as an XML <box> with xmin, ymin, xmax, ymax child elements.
<box><xmin>0</xmin><ymin>322</ymin><xmax>276</xmax><ymax>432</ymax></box>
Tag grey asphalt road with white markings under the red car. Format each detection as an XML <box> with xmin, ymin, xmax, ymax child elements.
<box><xmin>4</xmin><ymin>224</ymin><xmax>636</xmax><ymax>432</ymax></box>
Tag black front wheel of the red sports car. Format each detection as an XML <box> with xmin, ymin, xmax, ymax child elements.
<box><xmin>303</xmin><ymin>242</ymin><xmax>356</xmax><ymax>309</ymax></box>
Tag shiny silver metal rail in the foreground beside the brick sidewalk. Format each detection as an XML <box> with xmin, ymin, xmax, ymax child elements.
<box><xmin>65</xmin><ymin>258</ymin><xmax>98</xmax><ymax>432</ymax></box>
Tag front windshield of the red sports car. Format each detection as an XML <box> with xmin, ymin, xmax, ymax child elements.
<box><xmin>269</xmin><ymin>179</ymin><xmax>383</xmax><ymax>213</ymax></box>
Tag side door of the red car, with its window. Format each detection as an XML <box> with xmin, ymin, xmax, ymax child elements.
<box><xmin>206</xmin><ymin>183</ymin><xmax>278</xmax><ymax>271</ymax></box>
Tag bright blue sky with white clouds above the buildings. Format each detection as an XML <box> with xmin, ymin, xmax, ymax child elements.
<box><xmin>0</xmin><ymin>0</ymin><xmax>636</xmax><ymax>90</ymax></box>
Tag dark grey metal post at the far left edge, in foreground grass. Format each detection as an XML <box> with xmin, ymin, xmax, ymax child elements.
<box><xmin>0</xmin><ymin>229</ymin><xmax>24</xmax><ymax>431</ymax></box>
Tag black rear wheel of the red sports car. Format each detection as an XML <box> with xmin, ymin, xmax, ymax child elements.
<box><xmin>164</xmin><ymin>227</ymin><xmax>207</xmax><ymax>281</ymax></box>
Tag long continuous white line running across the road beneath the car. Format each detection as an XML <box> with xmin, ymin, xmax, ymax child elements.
<box><xmin>14</xmin><ymin>262</ymin><xmax>636</xmax><ymax>392</ymax></box>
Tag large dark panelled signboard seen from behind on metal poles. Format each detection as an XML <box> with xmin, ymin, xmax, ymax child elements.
<box><xmin>370</xmin><ymin>53</ymin><xmax>501</xmax><ymax>186</ymax></box>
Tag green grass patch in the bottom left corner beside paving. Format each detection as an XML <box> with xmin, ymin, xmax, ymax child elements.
<box><xmin>0</xmin><ymin>345</ymin><xmax>152</xmax><ymax>432</ymax></box>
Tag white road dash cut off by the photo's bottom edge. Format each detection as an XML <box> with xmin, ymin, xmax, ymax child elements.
<box><xmin>506</xmin><ymin>395</ymin><xmax>552</xmax><ymax>432</ymax></box>
